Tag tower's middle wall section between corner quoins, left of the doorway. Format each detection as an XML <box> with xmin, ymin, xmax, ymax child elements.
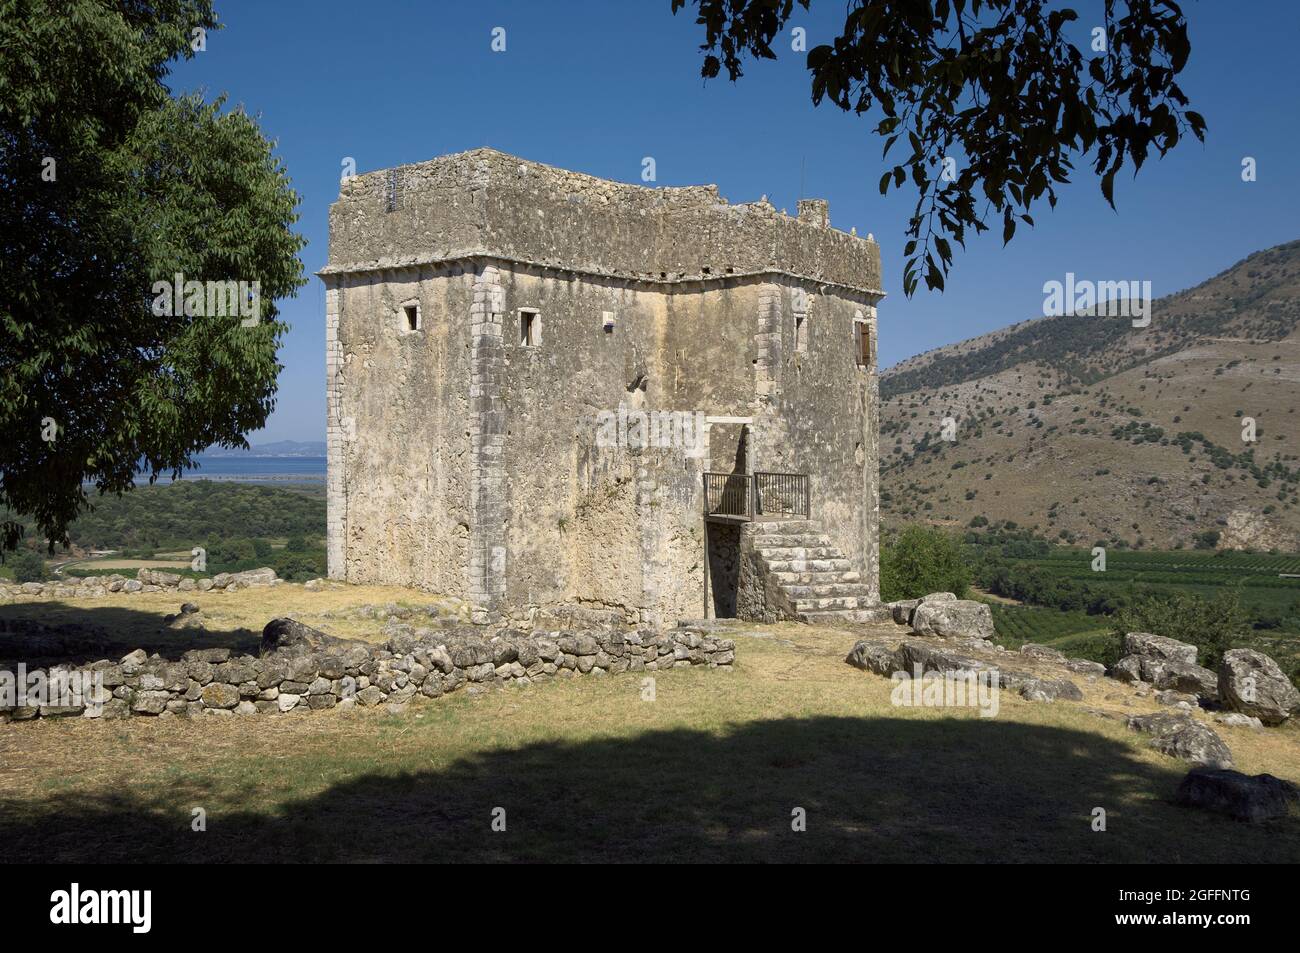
<box><xmin>488</xmin><ymin>265</ymin><xmax>757</xmax><ymax>623</ymax></box>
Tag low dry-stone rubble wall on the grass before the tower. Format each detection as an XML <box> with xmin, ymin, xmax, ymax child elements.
<box><xmin>0</xmin><ymin>620</ymin><xmax>736</xmax><ymax>722</ymax></box>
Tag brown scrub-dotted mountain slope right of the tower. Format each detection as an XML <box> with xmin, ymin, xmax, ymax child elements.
<box><xmin>880</xmin><ymin>242</ymin><xmax>1300</xmax><ymax>551</ymax></box>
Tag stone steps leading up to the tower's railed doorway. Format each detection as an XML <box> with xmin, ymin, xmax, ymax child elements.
<box><xmin>745</xmin><ymin>519</ymin><xmax>892</xmax><ymax>624</ymax></box>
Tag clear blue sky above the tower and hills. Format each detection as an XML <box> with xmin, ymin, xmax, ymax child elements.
<box><xmin>170</xmin><ymin>0</ymin><xmax>1300</xmax><ymax>443</ymax></box>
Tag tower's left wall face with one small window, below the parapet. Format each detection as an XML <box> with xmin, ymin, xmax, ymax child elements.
<box><xmin>329</xmin><ymin>265</ymin><xmax>476</xmax><ymax>598</ymax></box>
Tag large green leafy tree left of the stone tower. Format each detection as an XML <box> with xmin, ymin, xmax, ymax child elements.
<box><xmin>0</xmin><ymin>0</ymin><xmax>304</xmax><ymax>549</ymax></box>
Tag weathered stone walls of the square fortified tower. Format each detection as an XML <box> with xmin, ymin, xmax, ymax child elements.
<box><xmin>321</xmin><ymin>150</ymin><xmax>880</xmax><ymax>625</ymax></box>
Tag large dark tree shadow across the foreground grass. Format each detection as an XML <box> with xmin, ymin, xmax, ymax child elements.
<box><xmin>0</xmin><ymin>716</ymin><xmax>1300</xmax><ymax>863</ymax></box>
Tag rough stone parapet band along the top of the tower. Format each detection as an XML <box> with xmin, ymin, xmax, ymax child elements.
<box><xmin>325</xmin><ymin>150</ymin><xmax>880</xmax><ymax>289</ymax></box>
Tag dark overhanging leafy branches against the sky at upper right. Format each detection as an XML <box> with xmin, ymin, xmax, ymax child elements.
<box><xmin>672</xmin><ymin>0</ymin><xmax>1205</xmax><ymax>295</ymax></box>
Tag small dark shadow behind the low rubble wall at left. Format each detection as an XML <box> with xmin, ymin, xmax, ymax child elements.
<box><xmin>0</xmin><ymin>603</ymin><xmax>261</xmax><ymax>670</ymax></box>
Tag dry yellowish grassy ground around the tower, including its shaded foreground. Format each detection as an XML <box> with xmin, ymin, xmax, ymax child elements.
<box><xmin>0</xmin><ymin>586</ymin><xmax>1300</xmax><ymax>863</ymax></box>
